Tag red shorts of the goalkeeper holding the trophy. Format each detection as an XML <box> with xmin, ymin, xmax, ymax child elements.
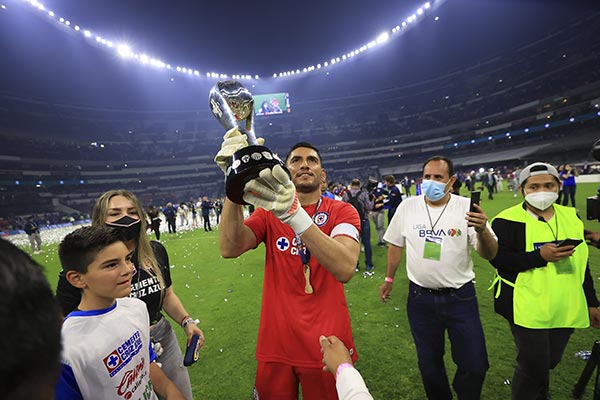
<box><xmin>255</xmin><ymin>361</ymin><xmax>338</xmax><ymax>400</ymax></box>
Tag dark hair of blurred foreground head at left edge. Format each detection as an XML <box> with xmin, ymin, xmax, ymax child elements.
<box><xmin>0</xmin><ymin>239</ymin><xmax>62</xmax><ymax>400</ymax></box>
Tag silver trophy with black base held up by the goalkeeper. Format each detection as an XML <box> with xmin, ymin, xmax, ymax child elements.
<box><xmin>208</xmin><ymin>81</ymin><xmax>289</xmax><ymax>204</ymax></box>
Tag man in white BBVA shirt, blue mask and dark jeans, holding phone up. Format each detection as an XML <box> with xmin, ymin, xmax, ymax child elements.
<box><xmin>379</xmin><ymin>156</ymin><xmax>498</xmax><ymax>400</ymax></box>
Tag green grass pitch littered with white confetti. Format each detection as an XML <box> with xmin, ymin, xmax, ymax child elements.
<box><xmin>35</xmin><ymin>184</ymin><xmax>600</xmax><ymax>400</ymax></box>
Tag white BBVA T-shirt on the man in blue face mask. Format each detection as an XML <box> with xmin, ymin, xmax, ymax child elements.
<box><xmin>383</xmin><ymin>194</ymin><xmax>496</xmax><ymax>289</ymax></box>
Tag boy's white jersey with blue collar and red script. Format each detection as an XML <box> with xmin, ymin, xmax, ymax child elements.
<box><xmin>56</xmin><ymin>297</ymin><xmax>157</xmax><ymax>400</ymax></box>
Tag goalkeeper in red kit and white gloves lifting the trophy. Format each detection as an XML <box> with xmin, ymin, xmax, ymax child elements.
<box><xmin>215</xmin><ymin>128</ymin><xmax>360</xmax><ymax>400</ymax></box>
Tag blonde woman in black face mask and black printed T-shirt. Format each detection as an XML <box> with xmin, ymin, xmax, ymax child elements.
<box><xmin>56</xmin><ymin>189</ymin><xmax>204</xmax><ymax>399</ymax></box>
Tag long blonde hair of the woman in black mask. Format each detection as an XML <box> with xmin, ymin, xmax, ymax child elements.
<box><xmin>92</xmin><ymin>189</ymin><xmax>164</xmax><ymax>290</ymax></box>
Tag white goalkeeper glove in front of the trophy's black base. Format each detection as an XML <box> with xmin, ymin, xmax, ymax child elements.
<box><xmin>244</xmin><ymin>165</ymin><xmax>312</xmax><ymax>235</ymax></box>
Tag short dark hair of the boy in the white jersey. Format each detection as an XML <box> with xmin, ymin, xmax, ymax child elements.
<box><xmin>58</xmin><ymin>226</ymin><xmax>125</xmax><ymax>274</ymax></box>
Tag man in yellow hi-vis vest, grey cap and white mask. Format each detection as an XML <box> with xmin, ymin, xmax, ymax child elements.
<box><xmin>490</xmin><ymin>162</ymin><xmax>600</xmax><ymax>400</ymax></box>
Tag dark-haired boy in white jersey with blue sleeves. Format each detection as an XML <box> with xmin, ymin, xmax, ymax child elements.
<box><xmin>56</xmin><ymin>227</ymin><xmax>184</xmax><ymax>400</ymax></box>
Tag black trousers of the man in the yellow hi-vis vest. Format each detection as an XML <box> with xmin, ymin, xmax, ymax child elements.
<box><xmin>509</xmin><ymin>323</ymin><xmax>573</xmax><ymax>400</ymax></box>
